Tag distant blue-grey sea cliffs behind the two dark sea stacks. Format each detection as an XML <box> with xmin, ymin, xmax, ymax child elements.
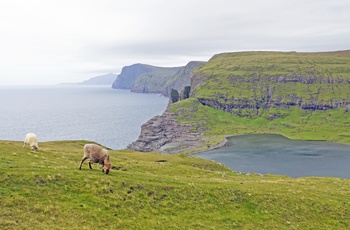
<box><xmin>112</xmin><ymin>61</ymin><xmax>205</xmax><ymax>96</ymax></box>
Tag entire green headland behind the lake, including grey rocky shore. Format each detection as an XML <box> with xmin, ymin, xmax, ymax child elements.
<box><xmin>130</xmin><ymin>51</ymin><xmax>350</xmax><ymax>152</ymax></box>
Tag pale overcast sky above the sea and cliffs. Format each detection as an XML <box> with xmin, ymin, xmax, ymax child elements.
<box><xmin>0</xmin><ymin>0</ymin><xmax>350</xmax><ymax>85</ymax></box>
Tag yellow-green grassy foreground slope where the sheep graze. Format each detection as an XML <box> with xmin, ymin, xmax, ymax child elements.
<box><xmin>0</xmin><ymin>141</ymin><xmax>350</xmax><ymax>229</ymax></box>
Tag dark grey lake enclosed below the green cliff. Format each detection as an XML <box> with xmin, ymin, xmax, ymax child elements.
<box><xmin>196</xmin><ymin>134</ymin><xmax>350</xmax><ymax>178</ymax></box>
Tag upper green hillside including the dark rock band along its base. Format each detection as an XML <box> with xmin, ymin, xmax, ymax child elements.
<box><xmin>192</xmin><ymin>51</ymin><xmax>350</xmax><ymax>115</ymax></box>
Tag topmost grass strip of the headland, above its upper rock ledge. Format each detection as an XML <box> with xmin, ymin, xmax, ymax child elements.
<box><xmin>195</xmin><ymin>51</ymin><xmax>350</xmax><ymax>76</ymax></box>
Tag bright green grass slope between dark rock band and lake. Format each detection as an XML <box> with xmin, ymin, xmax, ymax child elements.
<box><xmin>170</xmin><ymin>98</ymin><xmax>350</xmax><ymax>151</ymax></box>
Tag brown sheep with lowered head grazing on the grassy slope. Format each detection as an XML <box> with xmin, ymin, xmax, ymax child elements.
<box><xmin>79</xmin><ymin>144</ymin><xmax>112</xmax><ymax>174</ymax></box>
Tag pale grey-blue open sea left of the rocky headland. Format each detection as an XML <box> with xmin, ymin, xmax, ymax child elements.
<box><xmin>0</xmin><ymin>86</ymin><xmax>168</xmax><ymax>149</ymax></box>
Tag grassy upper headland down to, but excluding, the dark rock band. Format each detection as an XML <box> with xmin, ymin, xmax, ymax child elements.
<box><xmin>192</xmin><ymin>51</ymin><xmax>350</xmax><ymax>103</ymax></box>
